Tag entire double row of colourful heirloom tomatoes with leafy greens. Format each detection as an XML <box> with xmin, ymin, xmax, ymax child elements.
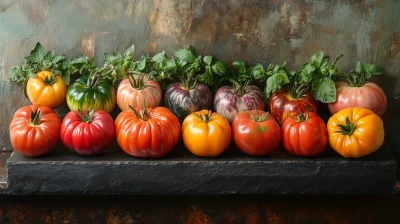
<box><xmin>9</xmin><ymin>43</ymin><xmax>387</xmax><ymax>158</ymax></box>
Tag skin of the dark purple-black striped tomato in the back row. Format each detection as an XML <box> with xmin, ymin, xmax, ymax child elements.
<box><xmin>164</xmin><ymin>83</ymin><xmax>213</xmax><ymax>121</ymax></box>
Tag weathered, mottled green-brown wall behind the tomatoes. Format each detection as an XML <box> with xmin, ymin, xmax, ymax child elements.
<box><xmin>0</xmin><ymin>0</ymin><xmax>400</xmax><ymax>150</ymax></box>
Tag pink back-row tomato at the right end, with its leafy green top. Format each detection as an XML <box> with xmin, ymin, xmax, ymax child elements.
<box><xmin>328</xmin><ymin>61</ymin><xmax>387</xmax><ymax>117</ymax></box>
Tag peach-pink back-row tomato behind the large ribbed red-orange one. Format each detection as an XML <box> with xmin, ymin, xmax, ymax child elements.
<box><xmin>117</xmin><ymin>75</ymin><xmax>162</xmax><ymax>111</ymax></box>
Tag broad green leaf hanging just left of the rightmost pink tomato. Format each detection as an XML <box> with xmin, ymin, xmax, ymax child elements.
<box><xmin>311</xmin><ymin>77</ymin><xmax>336</xmax><ymax>103</ymax></box>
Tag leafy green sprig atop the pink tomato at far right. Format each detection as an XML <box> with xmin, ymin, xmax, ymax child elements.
<box><xmin>338</xmin><ymin>61</ymin><xmax>383</xmax><ymax>87</ymax></box>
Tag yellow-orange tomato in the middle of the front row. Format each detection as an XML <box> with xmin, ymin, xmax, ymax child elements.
<box><xmin>182</xmin><ymin>110</ymin><xmax>232</xmax><ymax>157</ymax></box>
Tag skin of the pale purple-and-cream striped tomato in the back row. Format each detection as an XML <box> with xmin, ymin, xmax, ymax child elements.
<box><xmin>214</xmin><ymin>85</ymin><xmax>265</xmax><ymax>122</ymax></box>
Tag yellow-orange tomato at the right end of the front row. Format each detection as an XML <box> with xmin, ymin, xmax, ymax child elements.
<box><xmin>327</xmin><ymin>107</ymin><xmax>385</xmax><ymax>158</ymax></box>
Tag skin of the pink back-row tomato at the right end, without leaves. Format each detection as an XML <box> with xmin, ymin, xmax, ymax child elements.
<box><xmin>328</xmin><ymin>81</ymin><xmax>387</xmax><ymax>117</ymax></box>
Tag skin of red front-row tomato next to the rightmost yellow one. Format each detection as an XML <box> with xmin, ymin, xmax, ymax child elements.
<box><xmin>282</xmin><ymin>112</ymin><xmax>328</xmax><ymax>156</ymax></box>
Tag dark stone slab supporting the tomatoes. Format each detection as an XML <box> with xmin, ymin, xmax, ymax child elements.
<box><xmin>7</xmin><ymin>138</ymin><xmax>396</xmax><ymax>194</ymax></box>
